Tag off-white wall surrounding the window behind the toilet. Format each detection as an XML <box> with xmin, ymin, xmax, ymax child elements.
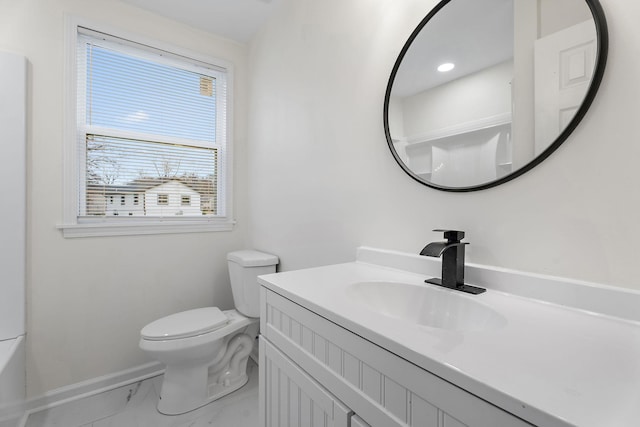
<box><xmin>0</xmin><ymin>0</ymin><xmax>247</xmax><ymax>396</ymax></box>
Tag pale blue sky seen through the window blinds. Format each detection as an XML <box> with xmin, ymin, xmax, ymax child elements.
<box><xmin>86</xmin><ymin>45</ymin><xmax>216</xmax><ymax>185</ymax></box>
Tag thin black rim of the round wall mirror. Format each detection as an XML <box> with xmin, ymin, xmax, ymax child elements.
<box><xmin>383</xmin><ymin>0</ymin><xmax>609</xmax><ymax>192</ymax></box>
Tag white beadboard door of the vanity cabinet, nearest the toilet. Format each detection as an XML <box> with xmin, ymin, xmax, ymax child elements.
<box><xmin>260</xmin><ymin>337</ymin><xmax>350</xmax><ymax>427</ymax></box>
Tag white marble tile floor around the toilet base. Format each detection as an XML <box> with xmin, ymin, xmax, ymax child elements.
<box><xmin>25</xmin><ymin>360</ymin><xmax>258</xmax><ymax>427</ymax></box>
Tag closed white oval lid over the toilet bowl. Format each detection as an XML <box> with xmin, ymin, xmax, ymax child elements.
<box><xmin>140</xmin><ymin>307</ymin><xmax>229</xmax><ymax>341</ymax></box>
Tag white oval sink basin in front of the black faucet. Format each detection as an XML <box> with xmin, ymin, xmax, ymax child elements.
<box><xmin>347</xmin><ymin>282</ymin><xmax>507</xmax><ymax>331</ymax></box>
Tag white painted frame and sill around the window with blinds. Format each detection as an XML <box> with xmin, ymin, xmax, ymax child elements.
<box><xmin>58</xmin><ymin>16</ymin><xmax>235</xmax><ymax>237</ymax></box>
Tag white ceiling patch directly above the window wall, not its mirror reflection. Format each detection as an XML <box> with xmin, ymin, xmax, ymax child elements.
<box><xmin>122</xmin><ymin>0</ymin><xmax>281</xmax><ymax>43</ymax></box>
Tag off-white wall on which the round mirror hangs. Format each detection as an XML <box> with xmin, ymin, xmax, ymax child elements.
<box><xmin>248</xmin><ymin>0</ymin><xmax>640</xmax><ymax>289</ymax></box>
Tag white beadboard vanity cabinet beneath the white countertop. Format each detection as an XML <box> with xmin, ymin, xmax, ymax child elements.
<box><xmin>260</xmin><ymin>287</ymin><xmax>531</xmax><ymax>427</ymax></box>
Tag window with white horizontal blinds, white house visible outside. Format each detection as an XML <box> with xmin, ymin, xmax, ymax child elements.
<box><xmin>62</xmin><ymin>25</ymin><xmax>232</xmax><ymax>236</ymax></box>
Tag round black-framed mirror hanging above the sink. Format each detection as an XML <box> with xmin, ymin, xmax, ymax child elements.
<box><xmin>384</xmin><ymin>0</ymin><xmax>608</xmax><ymax>191</ymax></box>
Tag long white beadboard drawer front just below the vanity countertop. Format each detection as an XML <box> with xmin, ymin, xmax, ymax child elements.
<box><xmin>261</xmin><ymin>288</ymin><xmax>531</xmax><ymax>427</ymax></box>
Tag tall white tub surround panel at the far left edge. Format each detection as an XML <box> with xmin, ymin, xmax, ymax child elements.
<box><xmin>0</xmin><ymin>52</ymin><xmax>27</xmax><ymax>340</ymax></box>
